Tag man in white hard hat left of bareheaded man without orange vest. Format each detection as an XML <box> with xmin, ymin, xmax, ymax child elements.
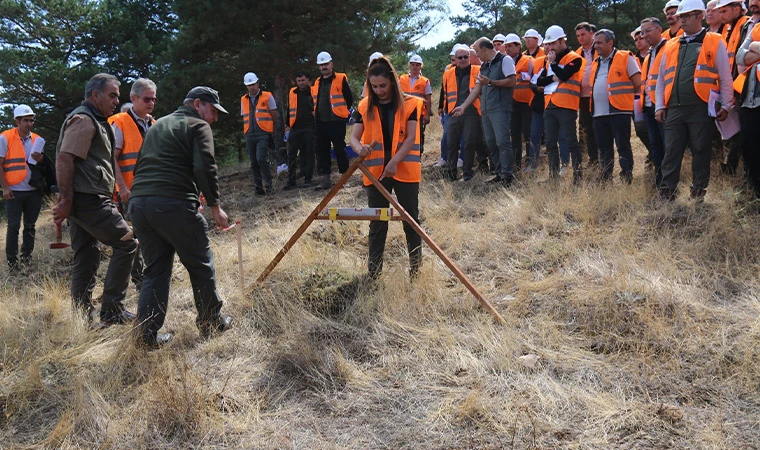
<box><xmin>439</xmin><ymin>45</ymin><xmax>488</xmax><ymax>181</ymax></box>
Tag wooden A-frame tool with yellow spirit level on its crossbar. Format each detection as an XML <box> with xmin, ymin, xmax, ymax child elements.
<box><xmin>256</xmin><ymin>148</ymin><xmax>506</xmax><ymax>324</ymax></box>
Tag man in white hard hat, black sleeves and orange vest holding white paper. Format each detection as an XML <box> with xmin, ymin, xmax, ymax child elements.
<box><xmin>536</xmin><ymin>25</ymin><xmax>583</xmax><ymax>183</ymax></box>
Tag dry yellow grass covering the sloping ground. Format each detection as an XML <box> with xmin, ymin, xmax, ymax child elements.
<box><xmin>0</xmin><ymin>124</ymin><xmax>760</xmax><ymax>449</ymax></box>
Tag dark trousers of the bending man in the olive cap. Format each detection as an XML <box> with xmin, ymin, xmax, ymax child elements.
<box><xmin>129</xmin><ymin>196</ymin><xmax>222</xmax><ymax>342</ymax></box>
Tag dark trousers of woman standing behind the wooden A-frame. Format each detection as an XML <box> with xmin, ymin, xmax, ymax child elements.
<box><xmin>364</xmin><ymin>178</ymin><xmax>422</xmax><ymax>277</ymax></box>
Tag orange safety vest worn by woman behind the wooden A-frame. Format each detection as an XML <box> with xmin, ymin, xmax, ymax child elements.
<box><xmin>358</xmin><ymin>96</ymin><xmax>422</xmax><ymax>186</ymax></box>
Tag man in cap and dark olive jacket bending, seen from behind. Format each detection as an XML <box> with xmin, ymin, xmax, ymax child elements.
<box><xmin>128</xmin><ymin>86</ymin><xmax>232</xmax><ymax>348</ymax></box>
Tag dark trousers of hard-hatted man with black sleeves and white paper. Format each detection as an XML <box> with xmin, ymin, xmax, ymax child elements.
<box><xmin>544</xmin><ymin>108</ymin><xmax>583</xmax><ymax>180</ymax></box>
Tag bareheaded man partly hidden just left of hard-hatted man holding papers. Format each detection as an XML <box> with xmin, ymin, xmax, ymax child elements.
<box><xmin>641</xmin><ymin>17</ymin><xmax>668</xmax><ymax>188</ymax></box>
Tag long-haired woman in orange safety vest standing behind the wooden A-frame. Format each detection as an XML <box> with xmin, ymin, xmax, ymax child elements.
<box><xmin>350</xmin><ymin>57</ymin><xmax>422</xmax><ymax>278</ymax></box>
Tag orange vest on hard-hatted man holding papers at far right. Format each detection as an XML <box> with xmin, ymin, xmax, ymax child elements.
<box><xmin>662</xmin><ymin>31</ymin><xmax>722</xmax><ymax>106</ymax></box>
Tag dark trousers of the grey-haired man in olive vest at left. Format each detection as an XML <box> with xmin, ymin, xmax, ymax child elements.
<box><xmin>69</xmin><ymin>193</ymin><xmax>137</xmax><ymax>321</ymax></box>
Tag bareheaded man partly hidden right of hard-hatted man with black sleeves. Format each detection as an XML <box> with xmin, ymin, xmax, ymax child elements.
<box><xmin>575</xmin><ymin>22</ymin><xmax>599</xmax><ymax>171</ymax></box>
